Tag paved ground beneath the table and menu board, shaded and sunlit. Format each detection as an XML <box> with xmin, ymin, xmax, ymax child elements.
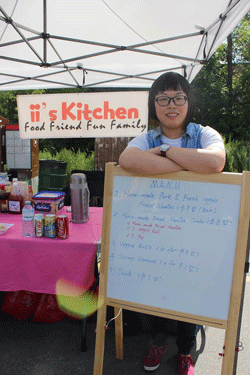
<box><xmin>0</xmin><ymin>277</ymin><xmax>250</xmax><ymax>375</ymax></box>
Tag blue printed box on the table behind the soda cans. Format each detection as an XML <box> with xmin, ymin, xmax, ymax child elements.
<box><xmin>33</xmin><ymin>191</ymin><xmax>65</xmax><ymax>214</ymax></box>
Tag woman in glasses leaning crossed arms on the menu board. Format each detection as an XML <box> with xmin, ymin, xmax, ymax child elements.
<box><xmin>119</xmin><ymin>72</ymin><xmax>226</xmax><ymax>375</ymax></box>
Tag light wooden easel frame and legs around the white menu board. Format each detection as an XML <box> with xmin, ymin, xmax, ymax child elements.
<box><xmin>94</xmin><ymin>163</ymin><xmax>250</xmax><ymax>375</ymax></box>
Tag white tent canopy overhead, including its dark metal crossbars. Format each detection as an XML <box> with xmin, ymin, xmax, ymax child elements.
<box><xmin>0</xmin><ymin>0</ymin><xmax>250</xmax><ymax>90</ymax></box>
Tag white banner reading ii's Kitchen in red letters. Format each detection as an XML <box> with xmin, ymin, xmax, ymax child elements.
<box><xmin>17</xmin><ymin>91</ymin><xmax>148</xmax><ymax>139</ymax></box>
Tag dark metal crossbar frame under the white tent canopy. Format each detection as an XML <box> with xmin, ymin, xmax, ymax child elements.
<box><xmin>0</xmin><ymin>0</ymin><xmax>240</xmax><ymax>88</ymax></box>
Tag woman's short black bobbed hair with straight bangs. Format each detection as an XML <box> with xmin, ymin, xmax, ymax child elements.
<box><xmin>148</xmin><ymin>72</ymin><xmax>195</xmax><ymax>128</ymax></box>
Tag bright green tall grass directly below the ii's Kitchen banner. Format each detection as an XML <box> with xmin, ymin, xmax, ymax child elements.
<box><xmin>39</xmin><ymin>148</ymin><xmax>95</xmax><ymax>182</ymax></box>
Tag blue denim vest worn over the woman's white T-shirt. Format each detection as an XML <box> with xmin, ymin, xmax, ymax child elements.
<box><xmin>146</xmin><ymin>122</ymin><xmax>204</xmax><ymax>148</ymax></box>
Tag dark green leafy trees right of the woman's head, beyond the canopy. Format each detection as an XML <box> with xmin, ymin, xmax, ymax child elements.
<box><xmin>193</xmin><ymin>12</ymin><xmax>250</xmax><ymax>140</ymax></box>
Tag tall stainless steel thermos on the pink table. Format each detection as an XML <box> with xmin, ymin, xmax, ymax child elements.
<box><xmin>70</xmin><ymin>173</ymin><xmax>89</xmax><ymax>223</ymax></box>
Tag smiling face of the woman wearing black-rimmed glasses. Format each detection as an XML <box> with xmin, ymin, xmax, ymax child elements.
<box><xmin>155</xmin><ymin>90</ymin><xmax>188</xmax><ymax>138</ymax></box>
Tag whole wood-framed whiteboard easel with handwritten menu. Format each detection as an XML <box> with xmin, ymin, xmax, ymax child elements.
<box><xmin>94</xmin><ymin>163</ymin><xmax>250</xmax><ymax>375</ymax></box>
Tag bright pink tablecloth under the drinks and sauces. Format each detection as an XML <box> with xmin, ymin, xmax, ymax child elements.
<box><xmin>0</xmin><ymin>207</ymin><xmax>102</xmax><ymax>294</ymax></box>
